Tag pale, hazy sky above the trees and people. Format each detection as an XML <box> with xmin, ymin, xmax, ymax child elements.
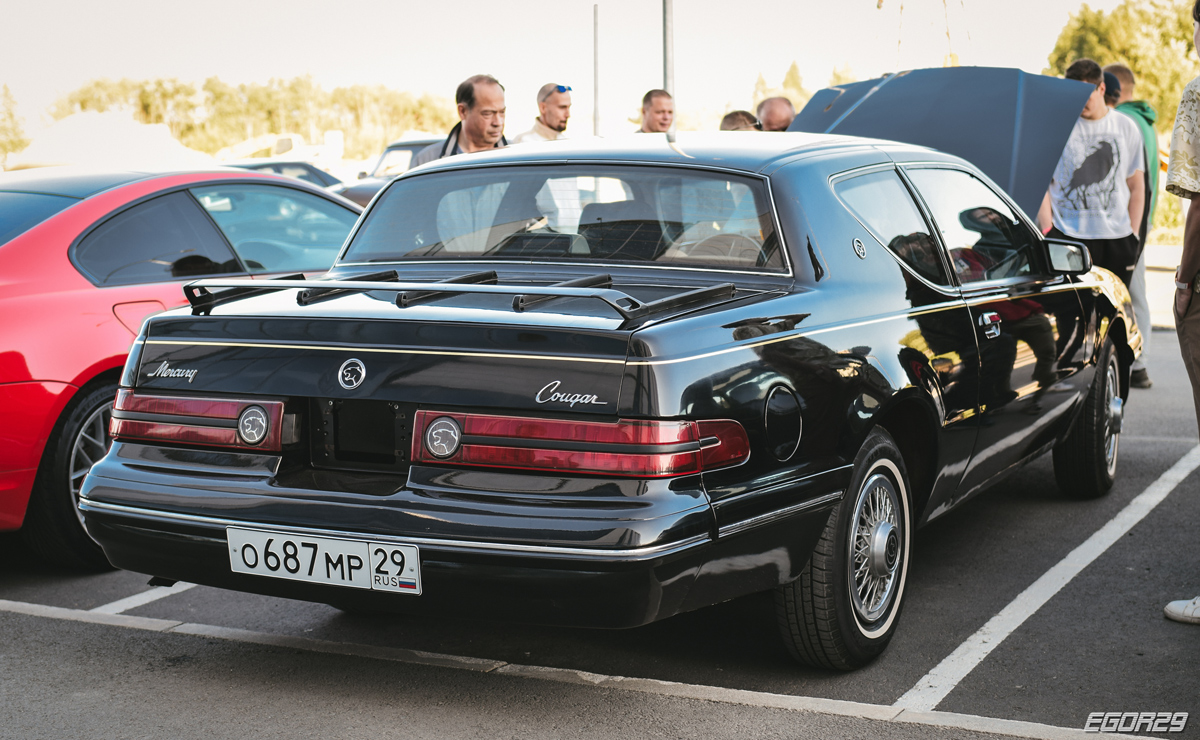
<box><xmin>0</xmin><ymin>0</ymin><xmax>1120</xmax><ymax>142</ymax></box>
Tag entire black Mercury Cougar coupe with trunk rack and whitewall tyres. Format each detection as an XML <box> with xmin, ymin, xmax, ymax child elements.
<box><xmin>80</xmin><ymin>133</ymin><xmax>1141</xmax><ymax>669</ymax></box>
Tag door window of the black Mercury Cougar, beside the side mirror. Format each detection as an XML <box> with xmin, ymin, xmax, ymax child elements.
<box><xmin>907</xmin><ymin>169</ymin><xmax>1038</xmax><ymax>284</ymax></box>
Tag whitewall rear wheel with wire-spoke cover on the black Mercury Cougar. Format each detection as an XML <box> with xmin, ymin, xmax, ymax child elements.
<box><xmin>775</xmin><ymin>429</ymin><xmax>912</xmax><ymax>670</ymax></box>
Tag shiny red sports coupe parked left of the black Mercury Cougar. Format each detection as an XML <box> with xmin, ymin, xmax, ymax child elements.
<box><xmin>0</xmin><ymin>168</ymin><xmax>361</xmax><ymax>568</ymax></box>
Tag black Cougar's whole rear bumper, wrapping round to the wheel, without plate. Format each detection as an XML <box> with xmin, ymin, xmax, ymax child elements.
<box><xmin>80</xmin><ymin>443</ymin><xmax>836</xmax><ymax>628</ymax></box>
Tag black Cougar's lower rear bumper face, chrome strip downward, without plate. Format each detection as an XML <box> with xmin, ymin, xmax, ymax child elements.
<box><xmin>83</xmin><ymin>501</ymin><xmax>708</xmax><ymax>627</ymax></box>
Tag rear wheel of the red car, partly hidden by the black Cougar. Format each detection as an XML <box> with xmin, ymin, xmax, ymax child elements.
<box><xmin>22</xmin><ymin>383</ymin><xmax>116</xmax><ymax>571</ymax></box>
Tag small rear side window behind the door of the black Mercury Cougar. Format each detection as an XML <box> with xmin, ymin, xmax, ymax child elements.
<box><xmin>834</xmin><ymin>169</ymin><xmax>949</xmax><ymax>285</ymax></box>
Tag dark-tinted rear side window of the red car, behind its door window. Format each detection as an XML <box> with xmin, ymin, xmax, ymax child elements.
<box><xmin>74</xmin><ymin>192</ymin><xmax>241</xmax><ymax>285</ymax></box>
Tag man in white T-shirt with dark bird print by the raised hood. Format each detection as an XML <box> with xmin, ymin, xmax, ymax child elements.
<box><xmin>1038</xmin><ymin>59</ymin><xmax>1146</xmax><ymax>285</ymax></box>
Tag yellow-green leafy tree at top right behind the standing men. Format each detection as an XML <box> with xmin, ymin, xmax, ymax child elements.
<box><xmin>1044</xmin><ymin>0</ymin><xmax>1200</xmax><ymax>133</ymax></box>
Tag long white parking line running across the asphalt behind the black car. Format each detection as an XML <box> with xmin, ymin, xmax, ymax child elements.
<box><xmin>0</xmin><ymin>600</ymin><xmax>1113</xmax><ymax>740</ymax></box>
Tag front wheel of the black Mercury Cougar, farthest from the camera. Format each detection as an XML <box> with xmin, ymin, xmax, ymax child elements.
<box><xmin>1054</xmin><ymin>339</ymin><xmax>1124</xmax><ymax>499</ymax></box>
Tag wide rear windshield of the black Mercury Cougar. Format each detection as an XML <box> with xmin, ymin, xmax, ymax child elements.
<box><xmin>342</xmin><ymin>164</ymin><xmax>787</xmax><ymax>272</ymax></box>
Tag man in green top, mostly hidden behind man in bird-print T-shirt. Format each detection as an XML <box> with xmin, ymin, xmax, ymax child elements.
<box><xmin>1104</xmin><ymin>65</ymin><xmax>1158</xmax><ymax>387</ymax></box>
